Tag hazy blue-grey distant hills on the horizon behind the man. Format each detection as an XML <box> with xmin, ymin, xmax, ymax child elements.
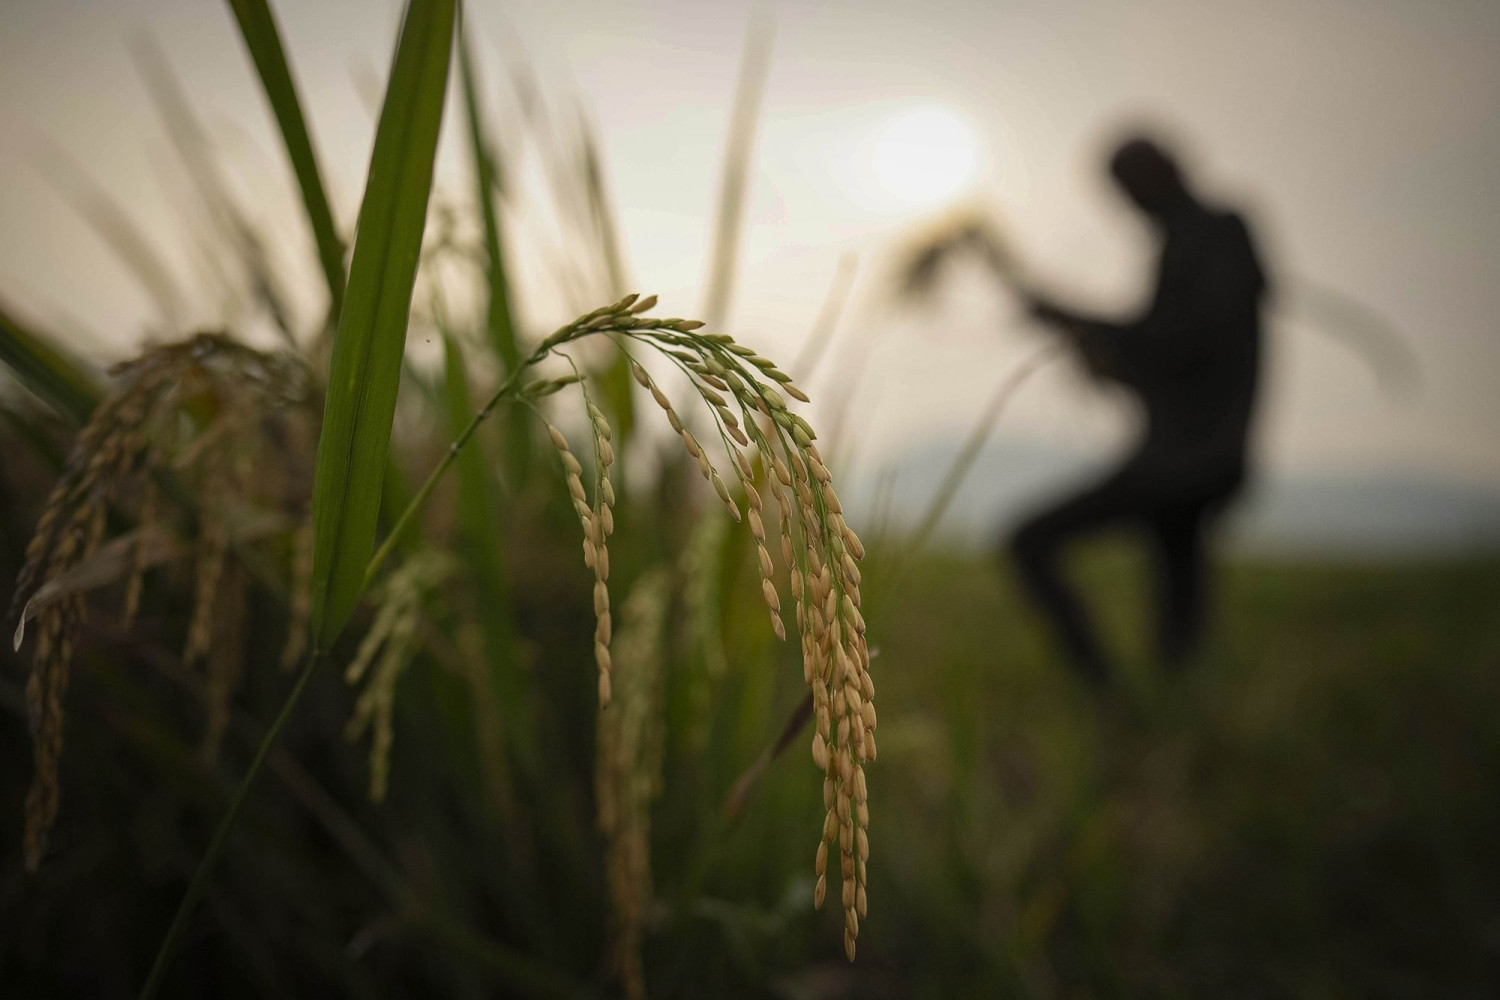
<box><xmin>840</xmin><ymin>438</ymin><xmax>1500</xmax><ymax>556</ymax></box>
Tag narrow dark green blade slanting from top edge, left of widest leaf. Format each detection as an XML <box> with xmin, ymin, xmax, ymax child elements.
<box><xmin>230</xmin><ymin>0</ymin><xmax>345</xmax><ymax>324</ymax></box>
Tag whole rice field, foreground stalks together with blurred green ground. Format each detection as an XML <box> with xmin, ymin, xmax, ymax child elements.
<box><xmin>0</xmin><ymin>0</ymin><xmax>1500</xmax><ymax>1000</ymax></box>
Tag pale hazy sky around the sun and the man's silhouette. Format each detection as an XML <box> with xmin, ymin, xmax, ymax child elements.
<box><xmin>0</xmin><ymin>0</ymin><xmax>1500</xmax><ymax>487</ymax></box>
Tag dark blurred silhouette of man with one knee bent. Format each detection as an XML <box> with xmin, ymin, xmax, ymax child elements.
<box><xmin>1010</xmin><ymin>138</ymin><xmax>1268</xmax><ymax>687</ymax></box>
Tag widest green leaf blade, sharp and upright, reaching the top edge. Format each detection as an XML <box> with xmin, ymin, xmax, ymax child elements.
<box><xmin>311</xmin><ymin>0</ymin><xmax>455</xmax><ymax>648</ymax></box>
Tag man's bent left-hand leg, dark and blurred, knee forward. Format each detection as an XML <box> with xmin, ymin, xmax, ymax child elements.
<box><xmin>1002</xmin><ymin>477</ymin><xmax>1133</xmax><ymax>687</ymax></box>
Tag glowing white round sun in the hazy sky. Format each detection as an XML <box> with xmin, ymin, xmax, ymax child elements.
<box><xmin>875</xmin><ymin>105</ymin><xmax>980</xmax><ymax>205</ymax></box>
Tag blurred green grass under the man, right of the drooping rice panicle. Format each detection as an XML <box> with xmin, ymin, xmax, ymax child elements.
<box><xmin>866</xmin><ymin>552</ymin><xmax>1500</xmax><ymax>997</ymax></box>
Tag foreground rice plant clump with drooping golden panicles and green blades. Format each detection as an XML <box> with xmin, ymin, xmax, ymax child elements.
<box><xmin>0</xmin><ymin>0</ymin><xmax>876</xmax><ymax>997</ymax></box>
